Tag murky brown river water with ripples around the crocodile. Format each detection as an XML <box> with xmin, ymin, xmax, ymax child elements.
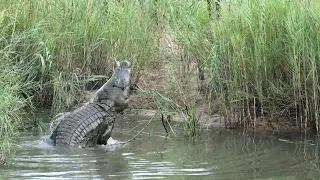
<box><xmin>2</xmin><ymin>116</ymin><xmax>320</xmax><ymax>180</ymax></box>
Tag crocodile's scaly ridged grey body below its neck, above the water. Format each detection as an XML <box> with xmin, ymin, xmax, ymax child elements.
<box><xmin>51</xmin><ymin>104</ymin><xmax>113</xmax><ymax>147</ymax></box>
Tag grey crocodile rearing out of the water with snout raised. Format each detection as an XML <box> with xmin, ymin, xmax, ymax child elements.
<box><xmin>50</xmin><ymin>61</ymin><xmax>131</xmax><ymax>148</ymax></box>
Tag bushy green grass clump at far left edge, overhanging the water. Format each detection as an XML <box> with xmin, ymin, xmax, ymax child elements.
<box><xmin>0</xmin><ymin>12</ymin><xmax>28</xmax><ymax>165</ymax></box>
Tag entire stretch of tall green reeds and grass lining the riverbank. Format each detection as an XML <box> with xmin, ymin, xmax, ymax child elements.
<box><xmin>0</xmin><ymin>0</ymin><xmax>320</xmax><ymax>162</ymax></box>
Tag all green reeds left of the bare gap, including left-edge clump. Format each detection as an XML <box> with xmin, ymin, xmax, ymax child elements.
<box><xmin>0</xmin><ymin>0</ymin><xmax>158</xmax><ymax>160</ymax></box>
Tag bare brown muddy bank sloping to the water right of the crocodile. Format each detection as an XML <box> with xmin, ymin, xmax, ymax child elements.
<box><xmin>85</xmin><ymin>62</ymin><xmax>315</xmax><ymax>134</ymax></box>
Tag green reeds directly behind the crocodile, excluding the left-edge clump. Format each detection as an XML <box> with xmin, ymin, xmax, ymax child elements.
<box><xmin>0</xmin><ymin>0</ymin><xmax>157</xmax><ymax>112</ymax></box>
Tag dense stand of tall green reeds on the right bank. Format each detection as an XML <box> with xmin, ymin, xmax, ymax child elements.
<box><xmin>207</xmin><ymin>0</ymin><xmax>320</xmax><ymax>130</ymax></box>
